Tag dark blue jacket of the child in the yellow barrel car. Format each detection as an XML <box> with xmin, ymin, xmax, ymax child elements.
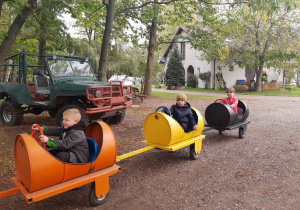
<box><xmin>170</xmin><ymin>102</ymin><xmax>196</xmax><ymax>126</ymax></box>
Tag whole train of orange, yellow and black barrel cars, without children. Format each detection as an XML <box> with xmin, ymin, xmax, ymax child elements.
<box><xmin>0</xmin><ymin>101</ymin><xmax>250</xmax><ymax>206</ymax></box>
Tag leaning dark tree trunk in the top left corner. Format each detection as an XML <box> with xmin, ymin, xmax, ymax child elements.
<box><xmin>0</xmin><ymin>0</ymin><xmax>37</xmax><ymax>70</ymax></box>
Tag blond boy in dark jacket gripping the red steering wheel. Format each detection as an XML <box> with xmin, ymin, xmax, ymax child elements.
<box><xmin>32</xmin><ymin>109</ymin><xmax>89</xmax><ymax>163</ymax></box>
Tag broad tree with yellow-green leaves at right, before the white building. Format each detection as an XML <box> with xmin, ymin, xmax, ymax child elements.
<box><xmin>185</xmin><ymin>0</ymin><xmax>299</xmax><ymax>91</ymax></box>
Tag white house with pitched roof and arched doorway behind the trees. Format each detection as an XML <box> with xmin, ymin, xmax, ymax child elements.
<box><xmin>160</xmin><ymin>26</ymin><xmax>283</xmax><ymax>89</ymax></box>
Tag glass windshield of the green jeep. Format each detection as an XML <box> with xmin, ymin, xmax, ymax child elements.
<box><xmin>48</xmin><ymin>59</ymin><xmax>94</xmax><ymax>77</ymax></box>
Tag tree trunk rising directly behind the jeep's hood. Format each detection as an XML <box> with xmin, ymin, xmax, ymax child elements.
<box><xmin>98</xmin><ymin>0</ymin><xmax>115</xmax><ymax>82</ymax></box>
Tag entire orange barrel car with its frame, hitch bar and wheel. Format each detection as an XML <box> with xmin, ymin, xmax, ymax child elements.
<box><xmin>0</xmin><ymin>121</ymin><xmax>120</xmax><ymax>205</ymax></box>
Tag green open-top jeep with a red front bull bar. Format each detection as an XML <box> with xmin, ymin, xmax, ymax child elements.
<box><xmin>0</xmin><ymin>51</ymin><xmax>133</xmax><ymax>126</ymax></box>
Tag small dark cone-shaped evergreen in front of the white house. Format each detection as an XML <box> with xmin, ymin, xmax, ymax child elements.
<box><xmin>166</xmin><ymin>44</ymin><xmax>185</xmax><ymax>87</ymax></box>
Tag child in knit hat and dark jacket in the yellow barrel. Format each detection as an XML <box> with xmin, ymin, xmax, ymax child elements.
<box><xmin>170</xmin><ymin>93</ymin><xmax>198</xmax><ymax>132</ymax></box>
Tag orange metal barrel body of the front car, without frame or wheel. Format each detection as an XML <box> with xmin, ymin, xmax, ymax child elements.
<box><xmin>14</xmin><ymin>121</ymin><xmax>117</xmax><ymax>192</ymax></box>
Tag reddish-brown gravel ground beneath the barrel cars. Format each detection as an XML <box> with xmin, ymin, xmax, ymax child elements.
<box><xmin>0</xmin><ymin>95</ymin><xmax>300</xmax><ymax>210</ymax></box>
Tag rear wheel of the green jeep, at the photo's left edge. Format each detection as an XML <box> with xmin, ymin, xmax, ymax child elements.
<box><xmin>0</xmin><ymin>100</ymin><xmax>24</xmax><ymax>126</ymax></box>
